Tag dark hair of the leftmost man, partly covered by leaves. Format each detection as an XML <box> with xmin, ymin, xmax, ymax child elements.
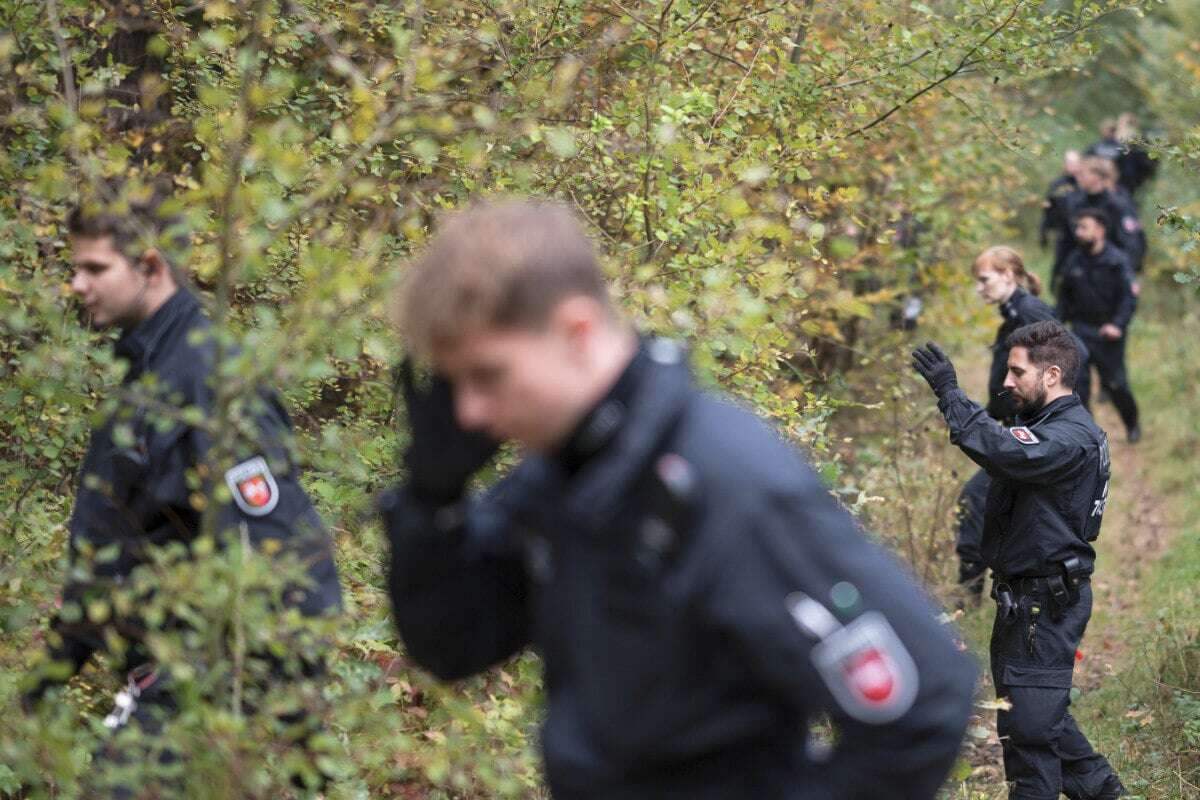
<box><xmin>67</xmin><ymin>178</ymin><xmax>190</xmax><ymax>277</ymax></box>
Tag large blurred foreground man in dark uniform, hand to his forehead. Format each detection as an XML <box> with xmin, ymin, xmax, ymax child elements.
<box><xmin>382</xmin><ymin>196</ymin><xmax>974</xmax><ymax>800</ymax></box>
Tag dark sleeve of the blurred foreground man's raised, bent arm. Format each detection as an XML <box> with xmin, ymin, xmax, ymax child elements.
<box><xmin>380</xmin><ymin>482</ymin><xmax>532</xmax><ymax>680</ymax></box>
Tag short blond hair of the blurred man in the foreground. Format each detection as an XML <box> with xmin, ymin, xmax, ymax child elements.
<box><xmin>395</xmin><ymin>199</ymin><xmax>612</xmax><ymax>356</ymax></box>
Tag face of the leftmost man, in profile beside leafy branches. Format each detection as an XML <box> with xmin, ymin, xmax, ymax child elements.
<box><xmin>71</xmin><ymin>236</ymin><xmax>148</xmax><ymax>327</ymax></box>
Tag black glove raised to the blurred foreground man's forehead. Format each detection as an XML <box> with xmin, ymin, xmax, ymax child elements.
<box><xmin>397</xmin><ymin>359</ymin><xmax>499</xmax><ymax>509</ymax></box>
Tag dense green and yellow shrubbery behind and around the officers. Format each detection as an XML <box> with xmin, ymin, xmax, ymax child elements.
<box><xmin>0</xmin><ymin>0</ymin><xmax>1180</xmax><ymax>798</ymax></box>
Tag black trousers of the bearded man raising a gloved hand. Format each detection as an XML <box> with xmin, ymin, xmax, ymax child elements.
<box><xmin>991</xmin><ymin>581</ymin><xmax>1121</xmax><ymax>800</ymax></box>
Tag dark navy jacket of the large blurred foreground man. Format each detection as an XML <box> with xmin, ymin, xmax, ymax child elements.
<box><xmin>385</xmin><ymin>342</ymin><xmax>976</xmax><ymax>800</ymax></box>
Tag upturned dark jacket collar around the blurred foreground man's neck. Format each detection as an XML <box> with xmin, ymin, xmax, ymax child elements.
<box><xmin>522</xmin><ymin>339</ymin><xmax>692</xmax><ymax>531</ymax></box>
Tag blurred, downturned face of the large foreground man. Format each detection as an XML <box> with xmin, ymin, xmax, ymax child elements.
<box><xmin>433</xmin><ymin>321</ymin><xmax>587</xmax><ymax>452</ymax></box>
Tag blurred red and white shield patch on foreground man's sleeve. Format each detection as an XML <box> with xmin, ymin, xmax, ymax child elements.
<box><xmin>812</xmin><ymin>612</ymin><xmax>918</xmax><ymax>724</ymax></box>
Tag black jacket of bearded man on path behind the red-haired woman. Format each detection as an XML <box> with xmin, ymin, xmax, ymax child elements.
<box><xmin>1057</xmin><ymin>242</ymin><xmax>1138</xmax><ymax>336</ymax></box>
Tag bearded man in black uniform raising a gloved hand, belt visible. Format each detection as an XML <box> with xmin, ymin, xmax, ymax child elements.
<box><xmin>913</xmin><ymin>321</ymin><xmax>1124</xmax><ymax>800</ymax></box>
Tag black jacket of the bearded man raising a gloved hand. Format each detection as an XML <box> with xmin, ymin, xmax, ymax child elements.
<box><xmin>937</xmin><ymin>389</ymin><xmax>1110</xmax><ymax>576</ymax></box>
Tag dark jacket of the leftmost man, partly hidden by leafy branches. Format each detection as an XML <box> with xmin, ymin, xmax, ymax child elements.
<box><xmin>52</xmin><ymin>289</ymin><xmax>341</xmax><ymax>670</ymax></box>
